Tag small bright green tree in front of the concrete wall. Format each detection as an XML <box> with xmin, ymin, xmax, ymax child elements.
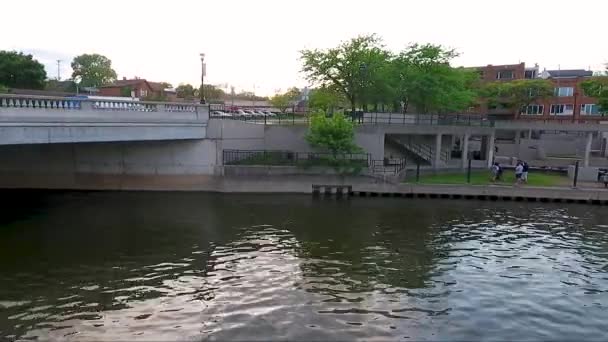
<box><xmin>306</xmin><ymin>113</ymin><xmax>361</xmax><ymax>157</ymax></box>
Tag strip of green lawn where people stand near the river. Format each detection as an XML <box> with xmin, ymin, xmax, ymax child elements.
<box><xmin>409</xmin><ymin>170</ymin><xmax>569</xmax><ymax>186</ymax></box>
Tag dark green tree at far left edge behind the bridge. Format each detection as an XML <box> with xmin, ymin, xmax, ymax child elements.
<box><xmin>0</xmin><ymin>51</ymin><xmax>46</xmax><ymax>89</ymax></box>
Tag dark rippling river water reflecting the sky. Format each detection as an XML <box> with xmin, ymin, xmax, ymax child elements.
<box><xmin>0</xmin><ymin>192</ymin><xmax>608</xmax><ymax>341</ymax></box>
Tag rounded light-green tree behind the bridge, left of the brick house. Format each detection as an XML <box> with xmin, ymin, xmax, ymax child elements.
<box><xmin>72</xmin><ymin>54</ymin><xmax>116</xmax><ymax>87</ymax></box>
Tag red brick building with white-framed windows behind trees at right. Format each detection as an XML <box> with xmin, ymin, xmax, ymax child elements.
<box><xmin>471</xmin><ymin>63</ymin><xmax>603</xmax><ymax>121</ymax></box>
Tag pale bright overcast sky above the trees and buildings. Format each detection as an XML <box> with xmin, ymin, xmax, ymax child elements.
<box><xmin>0</xmin><ymin>0</ymin><xmax>608</xmax><ymax>95</ymax></box>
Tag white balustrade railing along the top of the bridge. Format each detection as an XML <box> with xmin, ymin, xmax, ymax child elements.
<box><xmin>0</xmin><ymin>94</ymin><xmax>209</xmax><ymax>113</ymax></box>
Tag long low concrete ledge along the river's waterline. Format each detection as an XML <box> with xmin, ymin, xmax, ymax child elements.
<box><xmin>0</xmin><ymin>173</ymin><xmax>608</xmax><ymax>204</ymax></box>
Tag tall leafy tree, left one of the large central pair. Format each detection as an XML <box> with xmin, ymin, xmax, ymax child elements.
<box><xmin>300</xmin><ymin>35</ymin><xmax>388</xmax><ymax>112</ymax></box>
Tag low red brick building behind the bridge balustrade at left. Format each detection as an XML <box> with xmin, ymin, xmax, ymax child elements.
<box><xmin>99</xmin><ymin>77</ymin><xmax>177</xmax><ymax>101</ymax></box>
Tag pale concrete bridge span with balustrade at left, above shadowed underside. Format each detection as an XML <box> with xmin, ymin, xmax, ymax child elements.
<box><xmin>0</xmin><ymin>94</ymin><xmax>209</xmax><ymax>145</ymax></box>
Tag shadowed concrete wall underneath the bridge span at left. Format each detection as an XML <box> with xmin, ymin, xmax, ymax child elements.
<box><xmin>0</xmin><ymin>140</ymin><xmax>217</xmax><ymax>176</ymax></box>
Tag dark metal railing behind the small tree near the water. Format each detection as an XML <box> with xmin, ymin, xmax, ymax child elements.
<box><xmin>222</xmin><ymin>150</ymin><xmax>371</xmax><ymax>167</ymax></box>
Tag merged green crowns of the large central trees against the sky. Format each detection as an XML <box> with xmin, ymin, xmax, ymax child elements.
<box><xmin>301</xmin><ymin>35</ymin><xmax>478</xmax><ymax>113</ymax></box>
